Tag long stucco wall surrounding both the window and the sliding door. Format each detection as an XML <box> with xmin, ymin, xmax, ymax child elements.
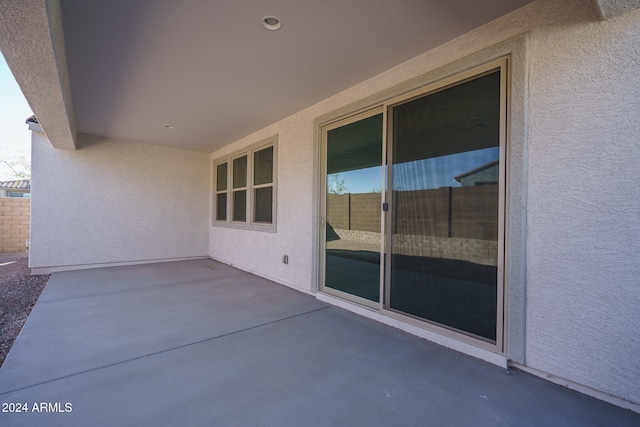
<box><xmin>209</xmin><ymin>0</ymin><xmax>640</xmax><ymax>403</ymax></box>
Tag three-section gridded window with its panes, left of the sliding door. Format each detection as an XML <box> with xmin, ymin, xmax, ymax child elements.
<box><xmin>213</xmin><ymin>137</ymin><xmax>277</xmax><ymax>231</ymax></box>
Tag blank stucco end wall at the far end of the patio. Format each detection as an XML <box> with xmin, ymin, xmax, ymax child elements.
<box><xmin>29</xmin><ymin>132</ymin><xmax>210</xmax><ymax>268</ymax></box>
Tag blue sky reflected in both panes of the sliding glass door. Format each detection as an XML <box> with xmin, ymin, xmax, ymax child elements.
<box><xmin>330</xmin><ymin>147</ymin><xmax>500</xmax><ymax>193</ymax></box>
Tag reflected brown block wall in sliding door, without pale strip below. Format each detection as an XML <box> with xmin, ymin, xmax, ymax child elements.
<box><xmin>327</xmin><ymin>185</ymin><xmax>498</xmax><ymax>241</ymax></box>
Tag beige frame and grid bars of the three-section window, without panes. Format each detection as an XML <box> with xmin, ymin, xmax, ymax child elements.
<box><xmin>211</xmin><ymin>135</ymin><xmax>278</xmax><ymax>233</ymax></box>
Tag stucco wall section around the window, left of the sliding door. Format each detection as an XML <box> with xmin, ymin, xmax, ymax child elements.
<box><xmin>209</xmin><ymin>118</ymin><xmax>315</xmax><ymax>292</ymax></box>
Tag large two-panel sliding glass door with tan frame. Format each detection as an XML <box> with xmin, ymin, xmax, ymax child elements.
<box><xmin>321</xmin><ymin>61</ymin><xmax>506</xmax><ymax>349</ymax></box>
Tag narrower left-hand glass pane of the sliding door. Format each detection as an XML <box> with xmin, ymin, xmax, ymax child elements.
<box><xmin>324</xmin><ymin>113</ymin><xmax>383</xmax><ymax>302</ymax></box>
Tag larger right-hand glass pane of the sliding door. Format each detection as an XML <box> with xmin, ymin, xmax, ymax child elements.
<box><xmin>385</xmin><ymin>70</ymin><xmax>502</xmax><ymax>342</ymax></box>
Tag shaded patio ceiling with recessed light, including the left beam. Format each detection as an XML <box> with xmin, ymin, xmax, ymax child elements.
<box><xmin>0</xmin><ymin>0</ymin><xmax>544</xmax><ymax>151</ymax></box>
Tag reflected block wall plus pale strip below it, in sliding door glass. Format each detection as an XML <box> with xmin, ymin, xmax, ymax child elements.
<box><xmin>327</xmin><ymin>185</ymin><xmax>498</xmax><ymax>266</ymax></box>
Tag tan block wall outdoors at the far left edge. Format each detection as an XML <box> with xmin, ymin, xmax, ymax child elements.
<box><xmin>0</xmin><ymin>197</ymin><xmax>31</xmax><ymax>253</ymax></box>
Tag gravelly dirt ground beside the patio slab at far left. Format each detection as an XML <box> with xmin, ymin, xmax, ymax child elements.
<box><xmin>0</xmin><ymin>253</ymin><xmax>49</xmax><ymax>366</ymax></box>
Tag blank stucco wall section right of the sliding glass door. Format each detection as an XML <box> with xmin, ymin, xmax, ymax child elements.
<box><xmin>526</xmin><ymin>3</ymin><xmax>640</xmax><ymax>403</ymax></box>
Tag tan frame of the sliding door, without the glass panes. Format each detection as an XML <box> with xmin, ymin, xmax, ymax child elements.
<box><xmin>317</xmin><ymin>55</ymin><xmax>511</xmax><ymax>355</ymax></box>
